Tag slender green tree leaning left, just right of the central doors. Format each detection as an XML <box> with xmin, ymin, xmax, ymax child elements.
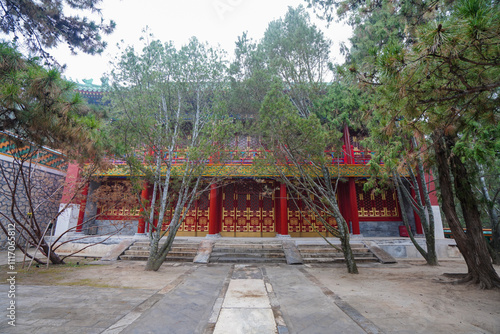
<box><xmin>259</xmin><ymin>83</ymin><xmax>358</xmax><ymax>274</ymax></box>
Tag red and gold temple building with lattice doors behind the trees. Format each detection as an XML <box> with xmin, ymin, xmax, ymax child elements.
<box><xmin>53</xmin><ymin>81</ymin><xmax>443</xmax><ymax>238</ymax></box>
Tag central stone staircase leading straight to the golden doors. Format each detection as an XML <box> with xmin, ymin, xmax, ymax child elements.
<box><xmin>209</xmin><ymin>239</ymin><xmax>286</xmax><ymax>263</ymax></box>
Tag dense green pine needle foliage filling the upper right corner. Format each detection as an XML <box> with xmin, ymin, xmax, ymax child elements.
<box><xmin>318</xmin><ymin>0</ymin><xmax>500</xmax><ymax>179</ymax></box>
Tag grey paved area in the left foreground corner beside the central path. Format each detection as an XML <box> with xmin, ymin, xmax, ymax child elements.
<box><xmin>0</xmin><ymin>284</ymin><xmax>156</xmax><ymax>334</ymax></box>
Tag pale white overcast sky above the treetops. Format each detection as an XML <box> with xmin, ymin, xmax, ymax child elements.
<box><xmin>51</xmin><ymin>0</ymin><xmax>351</xmax><ymax>84</ymax></box>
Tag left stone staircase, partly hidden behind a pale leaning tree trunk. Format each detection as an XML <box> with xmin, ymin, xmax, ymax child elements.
<box><xmin>120</xmin><ymin>239</ymin><xmax>200</xmax><ymax>262</ymax></box>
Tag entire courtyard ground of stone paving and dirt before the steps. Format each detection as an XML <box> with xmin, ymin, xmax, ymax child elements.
<box><xmin>0</xmin><ymin>261</ymin><xmax>500</xmax><ymax>334</ymax></box>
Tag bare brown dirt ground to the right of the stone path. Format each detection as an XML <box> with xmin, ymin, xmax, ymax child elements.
<box><xmin>308</xmin><ymin>261</ymin><xmax>500</xmax><ymax>334</ymax></box>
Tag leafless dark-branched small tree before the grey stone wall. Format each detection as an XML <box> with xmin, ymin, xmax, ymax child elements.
<box><xmin>0</xmin><ymin>144</ymin><xmax>125</xmax><ymax>264</ymax></box>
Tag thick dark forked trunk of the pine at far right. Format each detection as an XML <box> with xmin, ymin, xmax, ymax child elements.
<box><xmin>433</xmin><ymin>131</ymin><xmax>500</xmax><ymax>289</ymax></box>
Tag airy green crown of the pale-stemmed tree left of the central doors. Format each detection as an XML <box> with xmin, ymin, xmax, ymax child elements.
<box><xmin>109</xmin><ymin>38</ymin><xmax>232</xmax><ymax>166</ymax></box>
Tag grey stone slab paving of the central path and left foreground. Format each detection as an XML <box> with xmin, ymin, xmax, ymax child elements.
<box><xmin>0</xmin><ymin>264</ymin><xmax>381</xmax><ymax>334</ymax></box>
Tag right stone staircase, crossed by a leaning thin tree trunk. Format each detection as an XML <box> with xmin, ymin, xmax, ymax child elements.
<box><xmin>297</xmin><ymin>243</ymin><xmax>379</xmax><ymax>263</ymax></box>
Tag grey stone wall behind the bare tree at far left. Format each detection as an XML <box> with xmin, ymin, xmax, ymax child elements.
<box><xmin>0</xmin><ymin>157</ymin><xmax>65</xmax><ymax>249</ymax></box>
